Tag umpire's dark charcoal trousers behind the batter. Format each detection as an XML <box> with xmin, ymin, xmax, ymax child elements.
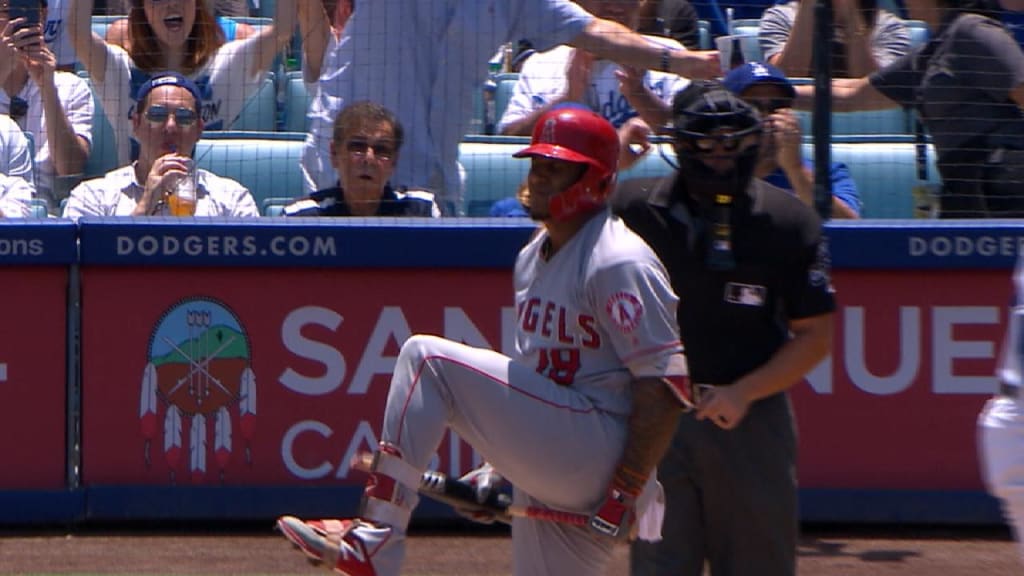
<box><xmin>630</xmin><ymin>394</ymin><xmax>799</xmax><ymax>576</ymax></box>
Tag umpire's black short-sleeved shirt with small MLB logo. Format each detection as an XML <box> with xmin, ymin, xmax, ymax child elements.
<box><xmin>612</xmin><ymin>172</ymin><xmax>836</xmax><ymax>384</ymax></box>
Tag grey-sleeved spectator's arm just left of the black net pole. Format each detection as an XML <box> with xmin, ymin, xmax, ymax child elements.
<box><xmin>758</xmin><ymin>0</ymin><xmax>814</xmax><ymax>78</ymax></box>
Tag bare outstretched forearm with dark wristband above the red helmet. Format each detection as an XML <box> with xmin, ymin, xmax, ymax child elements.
<box><xmin>568</xmin><ymin>18</ymin><xmax>721</xmax><ymax>79</ymax></box>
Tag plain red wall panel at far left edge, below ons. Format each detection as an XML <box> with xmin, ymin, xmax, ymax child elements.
<box><xmin>0</xmin><ymin>266</ymin><xmax>68</xmax><ymax>490</ymax></box>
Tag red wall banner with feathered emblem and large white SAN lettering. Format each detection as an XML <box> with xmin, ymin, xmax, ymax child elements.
<box><xmin>82</xmin><ymin>268</ymin><xmax>1010</xmax><ymax>489</ymax></box>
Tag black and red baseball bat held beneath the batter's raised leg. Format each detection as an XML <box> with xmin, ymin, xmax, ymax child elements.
<box><xmin>351</xmin><ymin>452</ymin><xmax>590</xmax><ymax>526</ymax></box>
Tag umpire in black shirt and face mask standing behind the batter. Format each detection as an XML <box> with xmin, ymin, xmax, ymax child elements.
<box><xmin>614</xmin><ymin>81</ymin><xmax>836</xmax><ymax>576</ymax></box>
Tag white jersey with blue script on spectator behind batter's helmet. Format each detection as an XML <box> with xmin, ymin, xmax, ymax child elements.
<box><xmin>498</xmin><ymin>36</ymin><xmax>690</xmax><ymax>130</ymax></box>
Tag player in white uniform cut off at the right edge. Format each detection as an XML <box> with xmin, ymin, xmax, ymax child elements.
<box><xmin>978</xmin><ymin>258</ymin><xmax>1024</xmax><ymax>563</ymax></box>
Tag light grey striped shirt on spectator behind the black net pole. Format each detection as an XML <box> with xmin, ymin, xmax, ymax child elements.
<box><xmin>758</xmin><ymin>0</ymin><xmax>910</xmax><ymax>73</ymax></box>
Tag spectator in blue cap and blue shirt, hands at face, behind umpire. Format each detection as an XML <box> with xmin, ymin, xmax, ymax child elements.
<box><xmin>722</xmin><ymin>63</ymin><xmax>860</xmax><ymax>218</ymax></box>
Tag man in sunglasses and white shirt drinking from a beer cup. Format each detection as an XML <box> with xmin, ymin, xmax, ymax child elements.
<box><xmin>63</xmin><ymin>72</ymin><xmax>259</xmax><ymax>219</ymax></box>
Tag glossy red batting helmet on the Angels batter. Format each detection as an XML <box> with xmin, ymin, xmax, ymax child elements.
<box><xmin>513</xmin><ymin>107</ymin><xmax>618</xmax><ymax>220</ymax></box>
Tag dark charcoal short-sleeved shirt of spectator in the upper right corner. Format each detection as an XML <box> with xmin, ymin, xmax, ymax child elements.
<box><xmin>869</xmin><ymin>13</ymin><xmax>1024</xmax><ymax>169</ymax></box>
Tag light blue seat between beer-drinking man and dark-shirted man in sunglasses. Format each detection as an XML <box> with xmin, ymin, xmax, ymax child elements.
<box><xmin>195</xmin><ymin>131</ymin><xmax>306</xmax><ymax>214</ymax></box>
